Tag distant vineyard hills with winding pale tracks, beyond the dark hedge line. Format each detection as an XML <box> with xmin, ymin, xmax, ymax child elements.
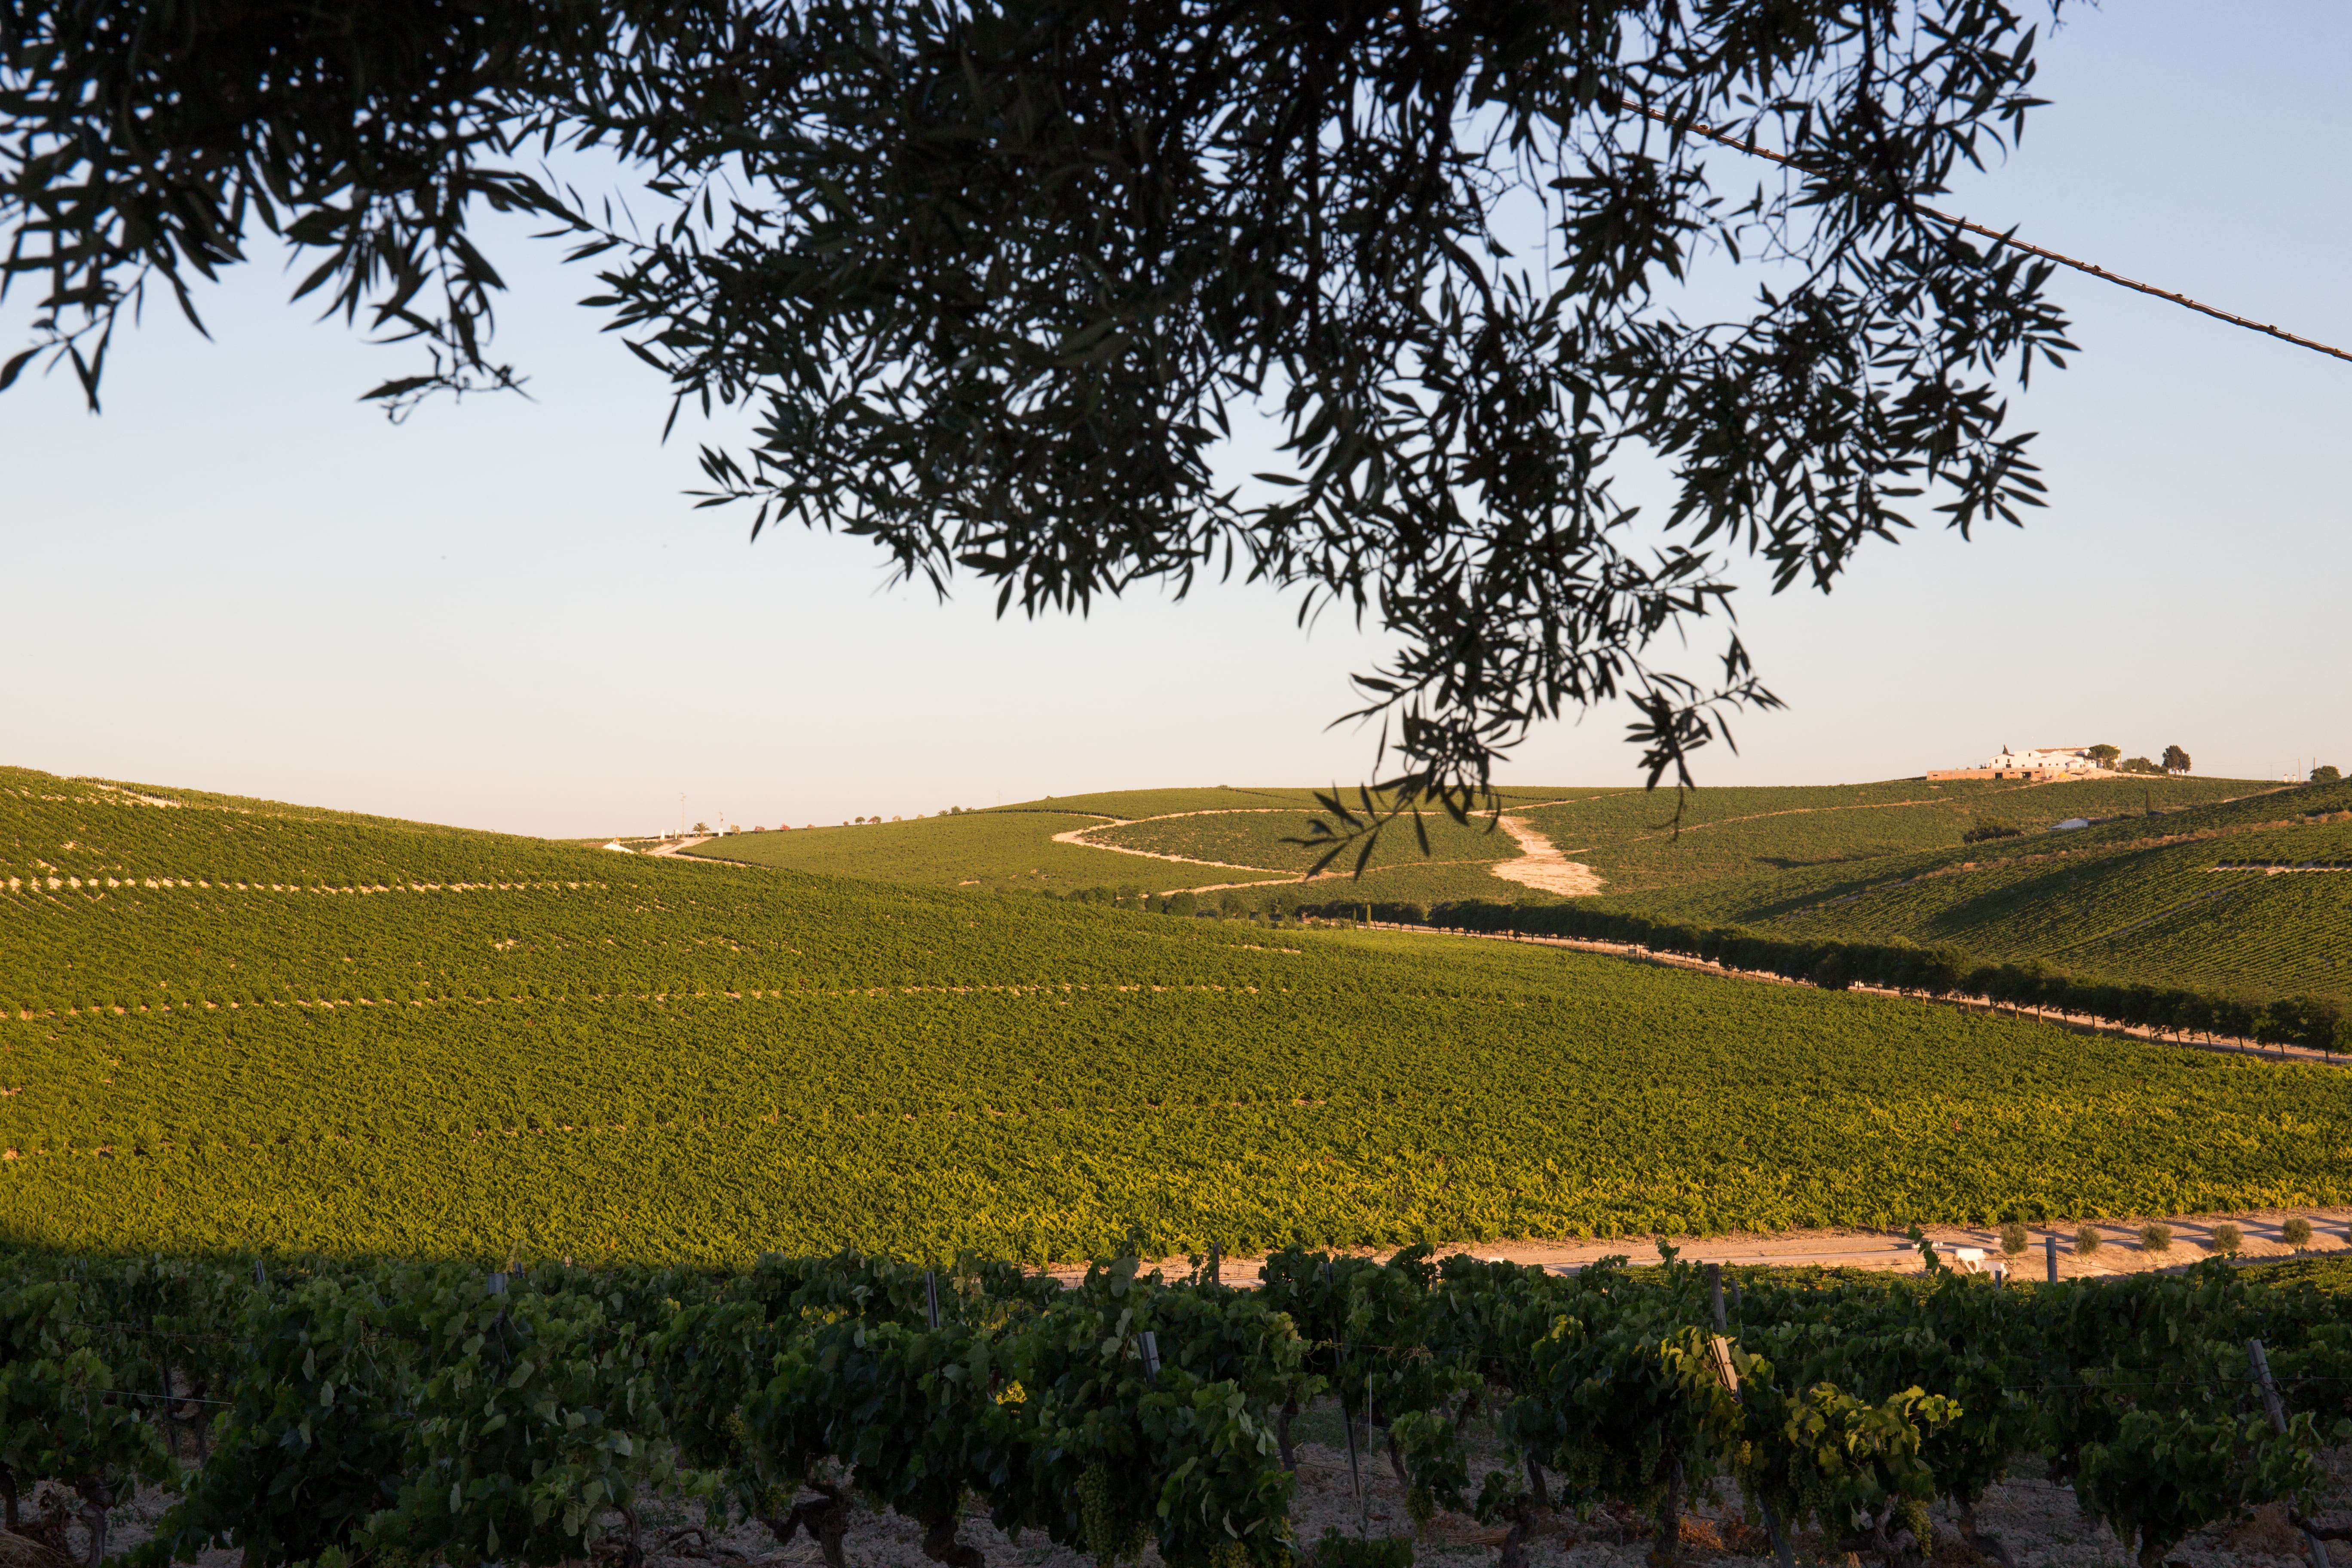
<box><xmin>703</xmin><ymin>778</ymin><xmax>2352</xmax><ymax>997</ymax></box>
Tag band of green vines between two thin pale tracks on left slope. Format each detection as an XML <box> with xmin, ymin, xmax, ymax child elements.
<box><xmin>0</xmin><ymin>851</ymin><xmax>1364</xmax><ymax>1011</ymax></box>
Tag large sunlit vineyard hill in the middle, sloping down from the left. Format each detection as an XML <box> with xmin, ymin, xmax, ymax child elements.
<box><xmin>0</xmin><ymin>771</ymin><xmax>2352</xmax><ymax>1260</ymax></box>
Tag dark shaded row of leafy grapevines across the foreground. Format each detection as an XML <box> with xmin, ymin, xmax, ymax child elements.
<box><xmin>14</xmin><ymin>1248</ymin><xmax>2352</xmax><ymax>1568</ymax></box>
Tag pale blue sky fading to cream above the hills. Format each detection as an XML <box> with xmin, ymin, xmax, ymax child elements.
<box><xmin>0</xmin><ymin>0</ymin><xmax>2352</xmax><ymax>835</ymax></box>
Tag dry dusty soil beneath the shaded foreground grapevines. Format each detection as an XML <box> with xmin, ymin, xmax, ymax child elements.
<box><xmin>41</xmin><ymin>1401</ymin><xmax>2352</xmax><ymax>1568</ymax></box>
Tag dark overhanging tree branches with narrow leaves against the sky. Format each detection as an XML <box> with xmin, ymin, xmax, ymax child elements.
<box><xmin>0</xmin><ymin>0</ymin><xmax>2067</xmax><ymax>811</ymax></box>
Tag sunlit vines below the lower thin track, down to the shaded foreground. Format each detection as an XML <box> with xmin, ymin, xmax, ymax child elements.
<box><xmin>0</xmin><ymin>945</ymin><xmax>2352</xmax><ymax>1265</ymax></box>
